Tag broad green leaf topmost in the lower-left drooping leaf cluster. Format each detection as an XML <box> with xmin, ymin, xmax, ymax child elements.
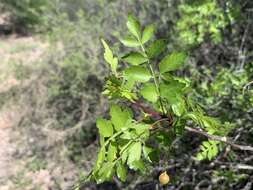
<box><xmin>110</xmin><ymin>104</ymin><xmax>132</xmax><ymax>131</ymax></box>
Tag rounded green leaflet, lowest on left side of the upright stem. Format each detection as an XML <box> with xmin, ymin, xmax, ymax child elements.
<box><xmin>140</xmin><ymin>83</ymin><xmax>158</xmax><ymax>103</ymax></box>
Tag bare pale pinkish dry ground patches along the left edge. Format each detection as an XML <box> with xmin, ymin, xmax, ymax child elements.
<box><xmin>0</xmin><ymin>35</ymin><xmax>50</xmax><ymax>190</ymax></box>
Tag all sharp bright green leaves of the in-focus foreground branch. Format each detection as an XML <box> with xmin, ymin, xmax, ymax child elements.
<box><xmin>86</xmin><ymin>14</ymin><xmax>230</xmax><ymax>186</ymax></box>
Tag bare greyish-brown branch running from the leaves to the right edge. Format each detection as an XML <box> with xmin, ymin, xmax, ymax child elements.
<box><xmin>185</xmin><ymin>127</ymin><xmax>253</xmax><ymax>151</ymax></box>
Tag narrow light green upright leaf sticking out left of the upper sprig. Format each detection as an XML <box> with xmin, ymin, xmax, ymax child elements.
<box><xmin>101</xmin><ymin>39</ymin><xmax>118</xmax><ymax>74</ymax></box>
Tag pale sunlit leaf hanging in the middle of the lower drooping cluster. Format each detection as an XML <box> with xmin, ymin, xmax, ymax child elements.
<box><xmin>127</xmin><ymin>142</ymin><xmax>141</xmax><ymax>166</ymax></box>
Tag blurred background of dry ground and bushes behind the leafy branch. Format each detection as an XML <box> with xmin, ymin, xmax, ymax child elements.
<box><xmin>0</xmin><ymin>0</ymin><xmax>253</xmax><ymax>190</ymax></box>
